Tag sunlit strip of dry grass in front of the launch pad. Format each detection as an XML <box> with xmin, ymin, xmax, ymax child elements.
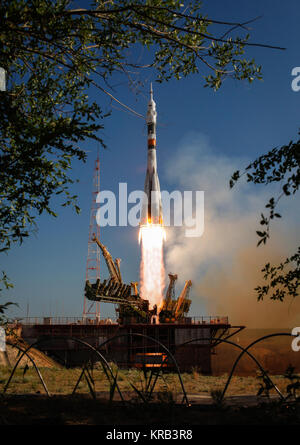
<box><xmin>0</xmin><ymin>367</ymin><xmax>296</xmax><ymax>399</ymax></box>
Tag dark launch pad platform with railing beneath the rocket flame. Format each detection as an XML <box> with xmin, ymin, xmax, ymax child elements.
<box><xmin>21</xmin><ymin>317</ymin><xmax>244</xmax><ymax>374</ymax></box>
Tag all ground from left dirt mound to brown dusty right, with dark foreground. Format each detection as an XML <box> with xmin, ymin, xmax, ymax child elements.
<box><xmin>0</xmin><ymin>331</ymin><xmax>300</xmax><ymax>427</ymax></box>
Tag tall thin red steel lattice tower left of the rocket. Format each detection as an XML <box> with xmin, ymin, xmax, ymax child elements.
<box><xmin>82</xmin><ymin>152</ymin><xmax>100</xmax><ymax>319</ymax></box>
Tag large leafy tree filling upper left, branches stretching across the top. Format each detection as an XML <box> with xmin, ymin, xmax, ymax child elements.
<box><xmin>0</xmin><ymin>0</ymin><xmax>286</xmax><ymax>308</ymax></box>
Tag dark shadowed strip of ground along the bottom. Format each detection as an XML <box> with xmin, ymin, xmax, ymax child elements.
<box><xmin>0</xmin><ymin>395</ymin><xmax>300</xmax><ymax>428</ymax></box>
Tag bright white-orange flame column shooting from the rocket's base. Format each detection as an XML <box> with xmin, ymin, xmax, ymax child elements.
<box><xmin>139</xmin><ymin>223</ymin><xmax>166</xmax><ymax>308</ymax></box>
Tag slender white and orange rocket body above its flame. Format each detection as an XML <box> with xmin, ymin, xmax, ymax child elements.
<box><xmin>140</xmin><ymin>83</ymin><xmax>163</xmax><ymax>226</ymax></box>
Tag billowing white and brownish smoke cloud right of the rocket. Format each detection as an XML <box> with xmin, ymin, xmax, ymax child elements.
<box><xmin>165</xmin><ymin>133</ymin><xmax>300</xmax><ymax>327</ymax></box>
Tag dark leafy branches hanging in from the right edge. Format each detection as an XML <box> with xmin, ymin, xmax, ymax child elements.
<box><xmin>230</xmin><ymin>134</ymin><xmax>300</xmax><ymax>301</ymax></box>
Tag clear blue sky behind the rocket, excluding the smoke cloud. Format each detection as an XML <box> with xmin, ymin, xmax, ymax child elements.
<box><xmin>2</xmin><ymin>0</ymin><xmax>300</xmax><ymax>324</ymax></box>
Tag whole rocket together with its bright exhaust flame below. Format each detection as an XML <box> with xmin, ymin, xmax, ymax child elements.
<box><xmin>139</xmin><ymin>84</ymin><xmax>165</xmax><ymax>310</ymax></box>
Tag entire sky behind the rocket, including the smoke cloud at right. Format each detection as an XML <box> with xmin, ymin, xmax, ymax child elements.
<box><xmin>1</xmin><ymin>0</ymin><xmax>300</xmax><ymax>327</ymax></box>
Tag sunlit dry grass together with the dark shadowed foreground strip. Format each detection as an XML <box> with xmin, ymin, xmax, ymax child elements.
<box><xmin>0</xmin><ymin>367</ymin><xmax>300</xmax><ymax>427</ymax></box>
